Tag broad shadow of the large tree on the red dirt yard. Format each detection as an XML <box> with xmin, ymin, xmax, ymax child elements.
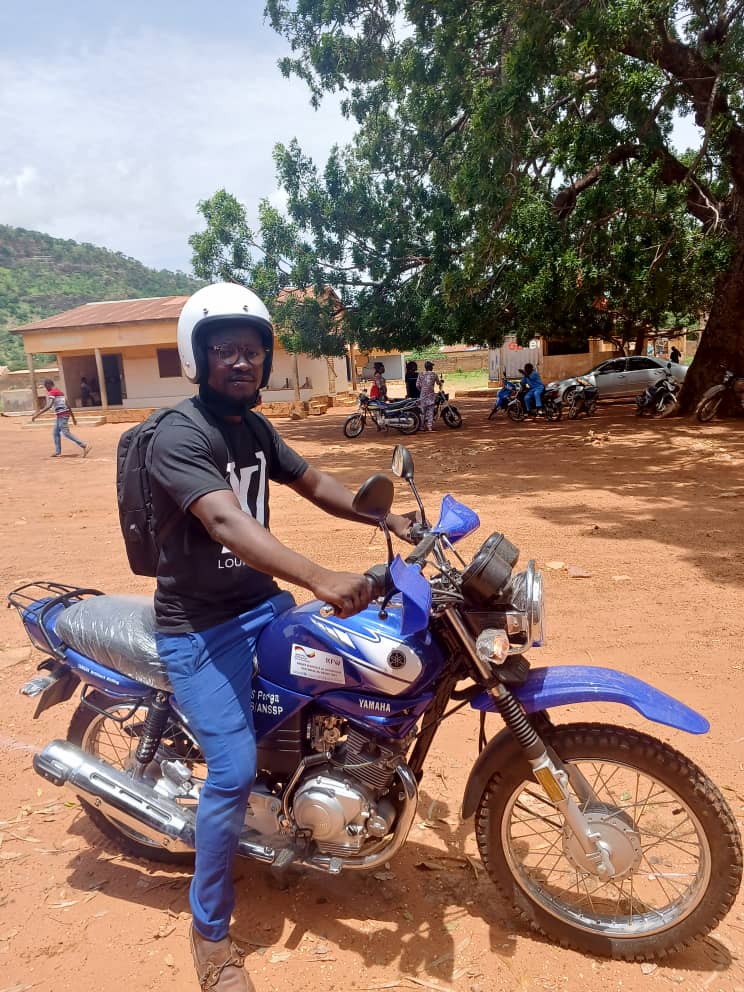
<box><xmin>279</xmin><ymin>398</ymin><xmax>744</xmax><ymax>585</ymax></box>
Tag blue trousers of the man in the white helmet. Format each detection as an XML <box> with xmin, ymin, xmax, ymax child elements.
<box><xmin>155</xmin><ymin>592</ymin><xmax>294</xmax><ymax>940</ymax></box>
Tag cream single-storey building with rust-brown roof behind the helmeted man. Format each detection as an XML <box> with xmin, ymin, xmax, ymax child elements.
<box><xmin>13</xmin><ymin>296</ymin><xmax>351</xmax><ymax>422</ymax></box>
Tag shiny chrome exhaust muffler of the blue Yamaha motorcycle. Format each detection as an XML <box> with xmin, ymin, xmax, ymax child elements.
<box><xmin>33</xmin><ymin>740</ymin><xmax>277</xmax><ymax>864</ymax></box>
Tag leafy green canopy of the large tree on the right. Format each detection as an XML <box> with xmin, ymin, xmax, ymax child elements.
<box><xmin>257</xmin><ymin>0</ymin><xmax>744</xmax><ymax>372</ymax></box>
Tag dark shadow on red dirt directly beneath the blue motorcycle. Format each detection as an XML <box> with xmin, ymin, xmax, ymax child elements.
<box><xmin>61</xmin><ymin>790</ymin><xmax>732</xmax><ymax>988</ymax></box>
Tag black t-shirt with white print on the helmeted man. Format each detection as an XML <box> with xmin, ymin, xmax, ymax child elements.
<box><xmin>150</xmin><ymin>413</ymin><xmax>308</xmax><ymax>633</ymax></box>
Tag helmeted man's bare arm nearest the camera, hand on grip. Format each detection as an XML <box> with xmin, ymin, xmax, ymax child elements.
<box><xmin>189</xmin><ymin>484</ymin><xmax>373</xmax><ymax>617</ymax></box>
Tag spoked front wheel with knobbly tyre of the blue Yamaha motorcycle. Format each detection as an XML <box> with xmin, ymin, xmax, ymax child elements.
<box><xmin>476</xmin><ymin>723</ymin><xmax>742</xmax><ymax>961</ymax></box>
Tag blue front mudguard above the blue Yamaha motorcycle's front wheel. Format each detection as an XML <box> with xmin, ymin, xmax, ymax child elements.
<box><xmin>470</xmin><ymin>665</ymin><xmax>710</xmax><ymax>734</ymax></box>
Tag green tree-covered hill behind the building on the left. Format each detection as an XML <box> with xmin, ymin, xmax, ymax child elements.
<box><xmin>0</xmin><ymin>224</ymin><xmax>203</xmax><ymax>369</ymax></box>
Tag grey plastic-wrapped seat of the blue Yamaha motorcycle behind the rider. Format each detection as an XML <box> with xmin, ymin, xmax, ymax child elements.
<box><xmin>55</xmin><ymin>596</ymin><xmax>173</xmax><ymax>692</ymax></box>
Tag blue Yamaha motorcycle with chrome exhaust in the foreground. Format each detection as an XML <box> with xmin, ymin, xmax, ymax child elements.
<box><xmin>9</xmin><ymin>445</ymin><xmax>742</xmax><ymax>960</ymax></box>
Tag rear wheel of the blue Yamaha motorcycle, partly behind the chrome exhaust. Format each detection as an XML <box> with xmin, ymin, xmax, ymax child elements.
<box><xmin>67</xmin><ymin>692</ymin><xmax>199</xmax><ymax>864</ymax></box>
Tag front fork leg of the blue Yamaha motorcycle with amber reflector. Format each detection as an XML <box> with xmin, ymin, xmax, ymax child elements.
<box><xmin>444</xmin><ymin>607</ymin><xmax>615</xmax><ymax>879</ymax></box>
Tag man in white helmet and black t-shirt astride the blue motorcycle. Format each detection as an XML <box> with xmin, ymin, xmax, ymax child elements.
<box><xmin>145</xmin><ymin>283</ymin><xmax>411</xmax><ymax>992</ymax></box>
